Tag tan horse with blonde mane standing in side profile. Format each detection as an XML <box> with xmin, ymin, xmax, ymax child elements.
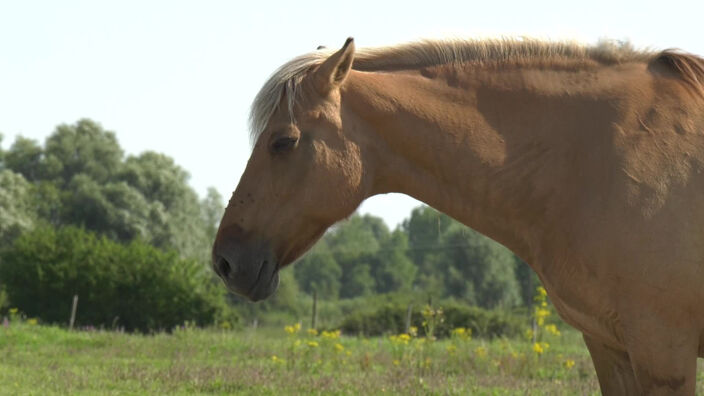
<box><xmin>213</xmin><ymin>39</ymin><xmax>704</xmax><ymax>395</ymax></box>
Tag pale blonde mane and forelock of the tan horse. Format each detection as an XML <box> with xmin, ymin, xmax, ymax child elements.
<box><xmin>249</xmin><ymin>39</ymin><xmax>657</xmax><ymax>143</ymax></box>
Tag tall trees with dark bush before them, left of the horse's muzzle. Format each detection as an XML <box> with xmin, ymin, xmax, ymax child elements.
<box><xmin>0</xmin><ymin>119</ymin><xmax>226</xmax><ymax>331</ymax></box>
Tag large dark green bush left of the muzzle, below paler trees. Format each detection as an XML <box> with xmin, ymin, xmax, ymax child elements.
<box><xmin>0</xmin><ymin>226</ymin><xmax>226</xmax><ymax>331</ymax></box>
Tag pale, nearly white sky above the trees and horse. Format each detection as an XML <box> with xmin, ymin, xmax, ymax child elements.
<box><xmin>0</xmin><ymin>0</ymin><xmax>704</xmax><ymax>227</ymax></box>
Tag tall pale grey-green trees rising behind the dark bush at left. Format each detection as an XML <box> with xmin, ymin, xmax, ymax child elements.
<box><xmin>4</xmin><ymin>119</ymin><xmax>222</xmax><ymax>261</ymax></box>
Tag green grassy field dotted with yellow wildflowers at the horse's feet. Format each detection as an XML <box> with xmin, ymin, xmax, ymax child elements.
<box><xmin>0</xmin><ymin>320</ymin><xmax>704</xmax><ymax>395</ymax></box>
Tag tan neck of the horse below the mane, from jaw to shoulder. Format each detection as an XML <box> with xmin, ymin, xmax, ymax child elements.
<box><xmin>343</xmin><ymin>66</ymin><xmax>592</xmax><ymax>260</ymax></box>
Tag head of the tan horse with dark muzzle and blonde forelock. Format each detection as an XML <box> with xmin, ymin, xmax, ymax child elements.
<box><xmin>213</xmin><ymin>39</ymin><xmax>369</xmax><ymax>301</ymax></box>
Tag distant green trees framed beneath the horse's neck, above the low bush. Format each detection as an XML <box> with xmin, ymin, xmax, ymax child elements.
<box><xmin>294</xmin><ymin>206</ymin><xmax>537</xmax><ymax>308</ymax></box>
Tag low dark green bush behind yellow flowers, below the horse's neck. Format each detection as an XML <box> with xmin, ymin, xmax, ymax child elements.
<box><xmin>339</xmin><ymin>302</ymin><xmax>530</xmax><ymax>338</ymax></box>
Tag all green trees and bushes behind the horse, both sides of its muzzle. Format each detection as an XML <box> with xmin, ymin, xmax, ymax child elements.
<box><xmin>0</xmin><ymin>119</ymin><xmax>539</xmax><ymax>336</ymax></box>
